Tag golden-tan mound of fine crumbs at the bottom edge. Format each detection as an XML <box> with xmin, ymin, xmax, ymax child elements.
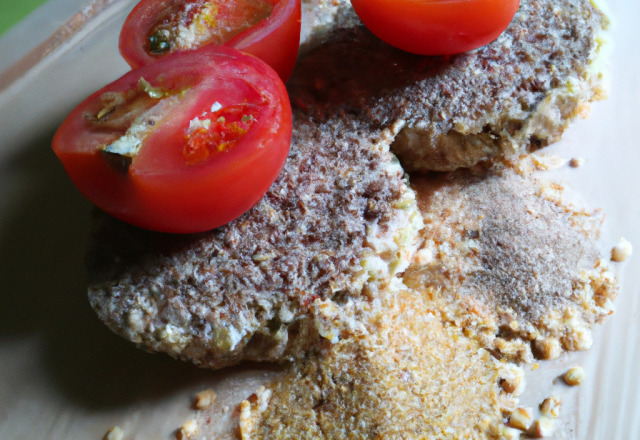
<box><xmin>240</xmin><ymin>291</ymin><xmax>515</xmax><ymax>440</ymax></box>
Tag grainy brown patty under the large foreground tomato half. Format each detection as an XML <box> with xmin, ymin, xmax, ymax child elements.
<box><xmin>87</xmin><ymin>111</ymin><xmax>421</xmax><ymax>368</ymax></box>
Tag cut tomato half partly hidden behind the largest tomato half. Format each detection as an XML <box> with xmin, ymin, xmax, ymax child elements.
<box><xmin>120</xmin><ymin>0</ymin><xmax>300</xmax><ymax>81</ymax></box>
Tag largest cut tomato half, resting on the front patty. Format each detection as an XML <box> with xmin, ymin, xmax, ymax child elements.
<box><xmin>53</xmin><ymin>46</ymin><xmax>291</xmax><ymax>233</ymax></box>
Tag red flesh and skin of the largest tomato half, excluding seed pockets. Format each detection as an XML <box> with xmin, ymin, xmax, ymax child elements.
<box><xmin>53</xmin><ymin>46</ymin><xmax>291</xmax><ymax>233</ymax></box>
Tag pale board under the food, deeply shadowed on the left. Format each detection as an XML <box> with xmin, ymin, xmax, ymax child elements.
<box><xmin>0</xmin><ymin>0</ymin><xmax>640</xmax><ymax>440</ymax></box>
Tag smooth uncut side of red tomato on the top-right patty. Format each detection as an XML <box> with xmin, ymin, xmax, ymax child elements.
<box><xmin>351</xmin><ymin>0</ymin><xmax>520</xmax><ymax>55</ymax></box>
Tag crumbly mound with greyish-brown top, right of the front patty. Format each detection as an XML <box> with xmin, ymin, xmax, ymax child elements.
<box><xmin>403</xmin><ymin>169</ymin><xmax>618</xmax><ymax>361</ymax></box>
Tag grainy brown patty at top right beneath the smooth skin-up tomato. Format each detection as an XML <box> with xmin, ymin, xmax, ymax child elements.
<box><xmin>288</xmin><ymin>0</ymin><xmax>608</xmax><ymax>171</ymax></box>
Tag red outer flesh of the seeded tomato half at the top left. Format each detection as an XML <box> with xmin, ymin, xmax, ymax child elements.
<box><xmin>119</xmin><ymin>0</ymin><xmax>301</xmax><ymax>82</ymax></box>
